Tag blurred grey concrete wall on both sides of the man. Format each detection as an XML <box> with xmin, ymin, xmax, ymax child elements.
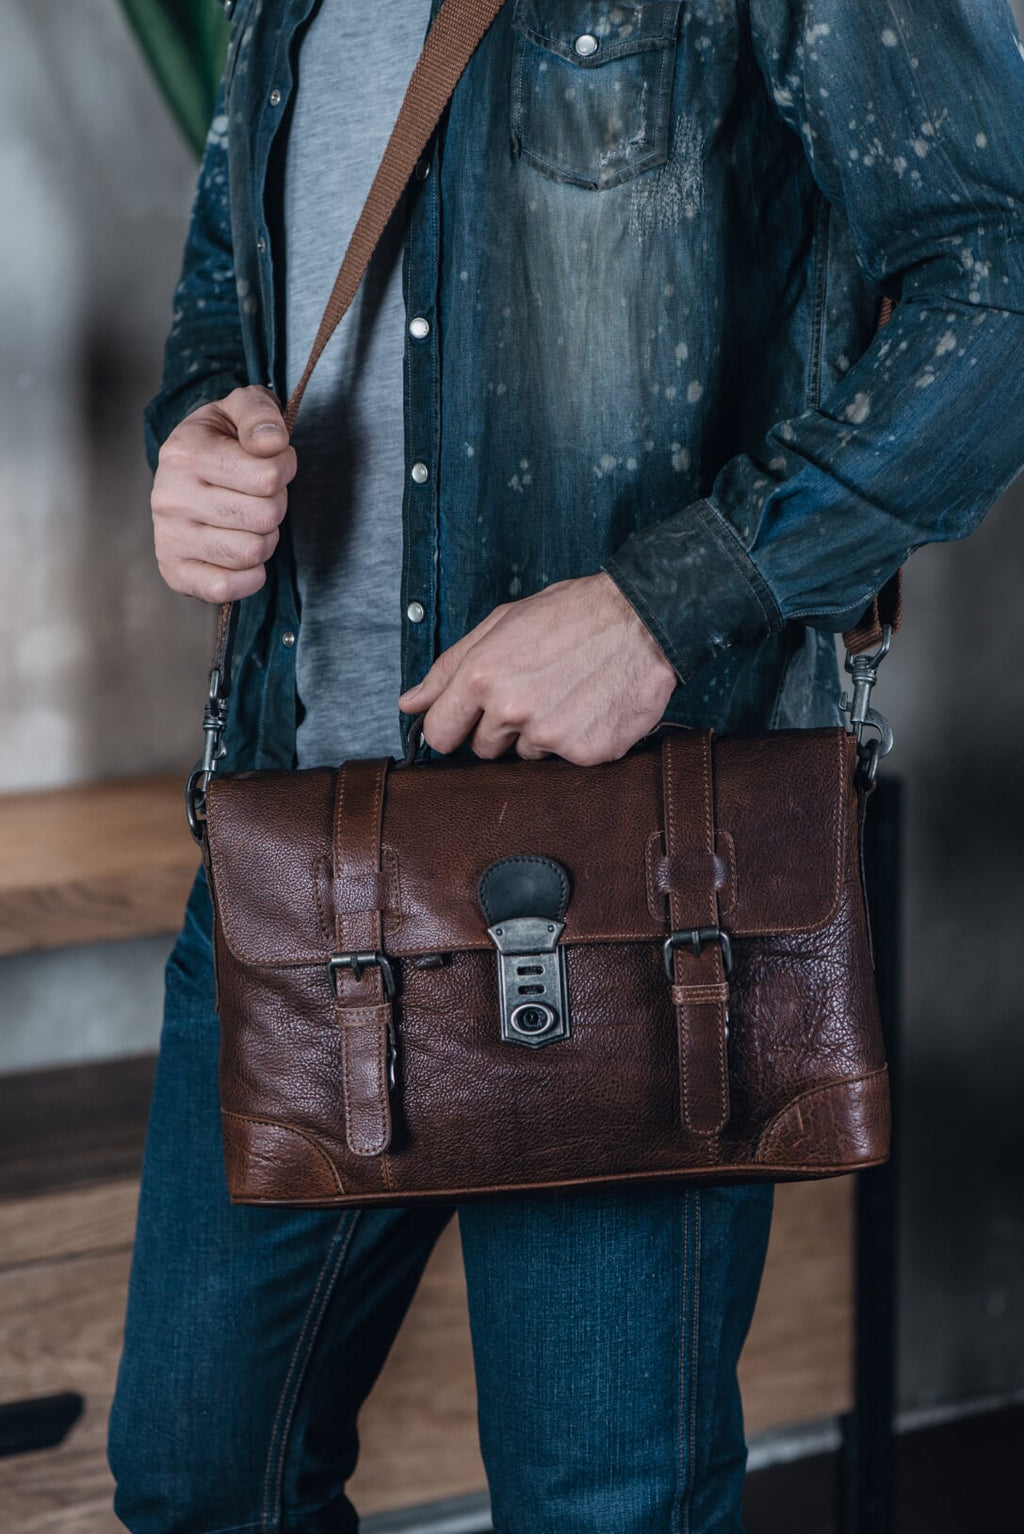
<box><xmin>0</xmin><ymin>0</ymin><xmax>1024</xmax><ymax>1407</ymax></box>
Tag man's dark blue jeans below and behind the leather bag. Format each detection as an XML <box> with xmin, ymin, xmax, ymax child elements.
<box><xmin>110</xmin><ymin>877</ymin><xmax>771</xmax><ymax>1534</ymax></box>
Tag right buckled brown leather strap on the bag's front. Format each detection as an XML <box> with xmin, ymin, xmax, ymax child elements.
<box><xmin>662</xmin><ymin>732</ymin><xmax>731</xmax><ymax>1137</ymax></box>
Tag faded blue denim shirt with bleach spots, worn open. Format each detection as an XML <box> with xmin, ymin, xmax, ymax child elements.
<box><xmin>147</xmin><ymin>0</ymin><xmax>1024</xmax><ymax>769</ymax></box>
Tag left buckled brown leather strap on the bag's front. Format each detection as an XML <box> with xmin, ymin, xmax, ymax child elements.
<box><xmin>328</xmin><ymin>756</ymin><xmax>397</xmax><ymax>1153</ymax></box>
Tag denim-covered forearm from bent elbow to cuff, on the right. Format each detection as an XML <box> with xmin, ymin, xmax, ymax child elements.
<box><xmin>606</xmin><ymin>301</ymin><xmax>1024</xmax><ymax>681</ymax></box>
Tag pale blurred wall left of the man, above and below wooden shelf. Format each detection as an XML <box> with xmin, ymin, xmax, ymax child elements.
<box><xmin>0</xmin><ymin>0</ymin><xmax>212</xmax><ymax>1071</ymax></box>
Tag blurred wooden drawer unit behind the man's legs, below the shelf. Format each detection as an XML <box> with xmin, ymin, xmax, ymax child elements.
<box><xmin>0</xmin><ymin>1058</ymin><xmax>852</xmax><ymax>1534</ymax></box>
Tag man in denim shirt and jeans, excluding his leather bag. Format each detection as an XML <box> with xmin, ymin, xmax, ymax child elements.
<box><xmin>112</xmin><ymin>0</ymin><xmax>1024</xmax><ymax>1534</ymax></box>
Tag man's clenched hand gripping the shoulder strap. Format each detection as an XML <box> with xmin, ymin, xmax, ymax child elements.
<box><xmin>152</xmin><ymin>385</ymin><xmax>296</xmax><ymax>603</ymax></box>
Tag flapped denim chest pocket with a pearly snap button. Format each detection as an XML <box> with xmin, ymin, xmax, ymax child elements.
<box><xmin>512</xmin><ymin>0</ymin><xmax>682</xmax><ymax>190</ymax></box>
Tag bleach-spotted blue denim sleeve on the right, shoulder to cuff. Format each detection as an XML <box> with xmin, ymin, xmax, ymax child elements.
<box><xmin>606</xmin><ymin>0</ymin><xmax>1024</xmax><ymax>681</ymax></box>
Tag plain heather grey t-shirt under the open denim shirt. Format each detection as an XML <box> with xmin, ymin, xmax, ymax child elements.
<box><xmin>284</xmin><ymin>0</ymin><xmax>429</xmax><ymax>767</ymax></box>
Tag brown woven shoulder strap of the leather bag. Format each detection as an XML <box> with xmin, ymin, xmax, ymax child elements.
<box><xmin>185</xmin><ymin>0</ymin><xmax>901</xmax><ymax>842</ymax></box>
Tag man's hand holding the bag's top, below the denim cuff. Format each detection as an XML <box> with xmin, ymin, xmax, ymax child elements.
<box><xmin>399</xmin><ymin>572</ymin><xmax>676</xmax><ymax>767</ymax></box>
